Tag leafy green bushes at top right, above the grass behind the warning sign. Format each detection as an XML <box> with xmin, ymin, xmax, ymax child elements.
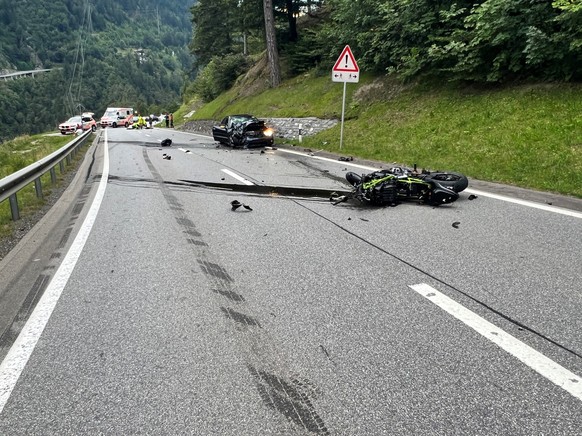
<box><xmin>322</xmin><ymin>0</ymin><xmax>582</xmax><ymax>82</ymax></box>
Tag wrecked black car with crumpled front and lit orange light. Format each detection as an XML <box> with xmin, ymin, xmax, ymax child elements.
<box><xmin>212</xmin><ymin>114</ymin><xmax>274</xmax><ymax>148</ymax></box>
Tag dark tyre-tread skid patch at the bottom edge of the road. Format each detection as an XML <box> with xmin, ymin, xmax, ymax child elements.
<box><xmin>248</xmin><ymin>365</ymin><xmax>330</xmax><ymax>435</ymax></box>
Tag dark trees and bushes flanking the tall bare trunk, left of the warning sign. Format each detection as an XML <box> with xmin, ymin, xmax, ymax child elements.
<box><xmin>184</xmin><ymin>0</ymin><xmax>325</xmax><ymax>101</ymax></box>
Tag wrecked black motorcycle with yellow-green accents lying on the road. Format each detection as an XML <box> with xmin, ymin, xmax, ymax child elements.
<box><xmin>331</xmin><ymin>165</ymin><xmax>469</xmax><ymax>206</ymax></box>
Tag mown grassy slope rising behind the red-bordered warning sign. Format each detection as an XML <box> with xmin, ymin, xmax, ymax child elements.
<box><xmin>182</xmin><ymin>75</ymin><xmax>582</xmax><ymax>198</ymax></box>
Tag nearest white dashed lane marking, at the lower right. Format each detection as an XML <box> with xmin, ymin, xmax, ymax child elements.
<box><xmin>410</xmin><ymin>283</ymin><xmax>582</xmax><ymax>401</ymax></box>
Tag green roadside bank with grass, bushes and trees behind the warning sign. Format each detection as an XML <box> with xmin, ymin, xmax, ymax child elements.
<box><xmin>185</xmin><ymin>0</ymin><xmax>582</xmax><ymax>198</ymax></box>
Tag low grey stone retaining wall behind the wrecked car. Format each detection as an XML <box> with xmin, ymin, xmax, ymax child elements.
<box><xmin>179</xmin><ymin>117</ymin><xmax>339</xmax><ymax>139</ymax></box>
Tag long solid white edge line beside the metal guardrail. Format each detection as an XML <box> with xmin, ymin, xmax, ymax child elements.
<box><xmin>0</xmin><ymin>130</ymin><xmax>109</xmax><ymax>413</ymax></box>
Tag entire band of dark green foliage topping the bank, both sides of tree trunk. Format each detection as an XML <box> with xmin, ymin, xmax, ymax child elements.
<box><xmin>191</xmin><ymin>0</ymin><xmax>582</xmax><ymax>95</ymax></box>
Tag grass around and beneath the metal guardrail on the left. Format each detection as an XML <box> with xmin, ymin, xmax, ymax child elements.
<box><xmin>0</xmin><ymin>135</ymin><xmax>82</xmax><ymax>238</ymax></box>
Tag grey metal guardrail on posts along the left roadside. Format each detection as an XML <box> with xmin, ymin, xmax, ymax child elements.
<box><xmin>0</xmin><ymin>130</ymin><xmax>92</xmax><ymax>221</ymax></box>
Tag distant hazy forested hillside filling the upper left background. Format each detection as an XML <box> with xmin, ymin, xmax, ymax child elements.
<box><xmin>0</xmin><ymin>0</ymin><xmax>195</xmax><ymax>140</ymax></box>
